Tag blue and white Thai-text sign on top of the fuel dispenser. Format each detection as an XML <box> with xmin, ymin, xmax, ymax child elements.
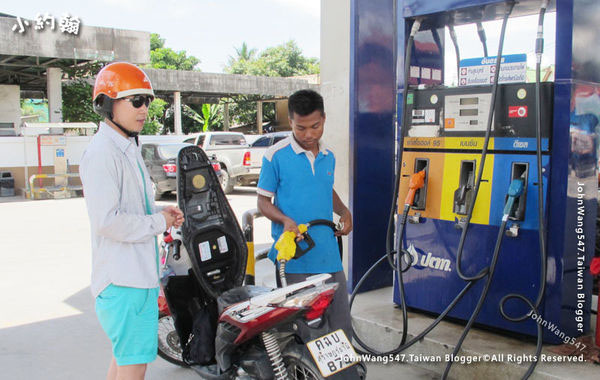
<box><xmin>458</xmin><ymin>54</ymin><xmax>527</xmax><ymax>86</ymax></box>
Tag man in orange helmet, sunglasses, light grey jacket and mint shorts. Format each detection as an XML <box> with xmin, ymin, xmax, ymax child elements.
<box><xmin>79</xmin><ymin>62</ymin><xmax>183</xmax><ymax>379</ymax></box>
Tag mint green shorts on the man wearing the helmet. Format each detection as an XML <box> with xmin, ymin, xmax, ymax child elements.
<box><xmin>96</xmin><ymin>284</ymin><xmax>158</xmax><ymax>366</ymax></box>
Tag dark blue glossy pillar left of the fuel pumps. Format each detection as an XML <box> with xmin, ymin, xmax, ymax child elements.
<box><xmin>348</xmin><ymin>0</ymin><xmax>396</xmax><ymax>290</ymax></box>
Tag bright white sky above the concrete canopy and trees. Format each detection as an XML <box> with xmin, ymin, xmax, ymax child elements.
<box><xmin>0</xmin><ymin>0</ymin><xmax>320</xmax><ymax>72</ymax></box>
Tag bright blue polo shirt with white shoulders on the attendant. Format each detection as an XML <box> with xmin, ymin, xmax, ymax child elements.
<box><xmin>257</xmin><ymin>136</ymin><xmax>343</xmax><ymax>273</ymax></box>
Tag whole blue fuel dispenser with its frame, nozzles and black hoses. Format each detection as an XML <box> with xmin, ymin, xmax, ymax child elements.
<box><xmin>351</xmin><ymin>0</ymin><xmax>600</xmax><ymax>378</ymax></box>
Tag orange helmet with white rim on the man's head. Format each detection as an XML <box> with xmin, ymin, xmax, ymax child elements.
<box><xmin>93</xmin><ymin>62</ymin><xmax>154</xmax><ymax>119</ymax></box>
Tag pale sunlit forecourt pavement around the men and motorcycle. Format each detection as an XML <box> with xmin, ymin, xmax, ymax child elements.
<box><xmin>0</xmin><ymin>191</ymin><xmax>432</xmax><ymax>380</ymax></box>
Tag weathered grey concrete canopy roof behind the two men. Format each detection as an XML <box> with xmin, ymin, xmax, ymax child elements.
<box><xmin>0</xmin><ymin>14</ymin><xmax>318</xmax><ymax>104</ymax></box>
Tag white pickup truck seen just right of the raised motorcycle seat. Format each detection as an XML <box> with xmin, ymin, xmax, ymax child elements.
<box><xmin>183</xmin><ymin>132</ymin><xmax>260</xmax><ymax>194</ymax></box>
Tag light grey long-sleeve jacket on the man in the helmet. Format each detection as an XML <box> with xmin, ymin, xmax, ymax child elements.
<box><xmin>79</xmin><ymin>123</ymin><xmax>166</xmax><ymax>297</ymax></box>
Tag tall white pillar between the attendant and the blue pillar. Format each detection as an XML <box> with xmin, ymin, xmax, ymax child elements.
<box><xmin>321</xmin><ymin>0</ymin><xmax>350</xmax><ymax>271</ymax></box>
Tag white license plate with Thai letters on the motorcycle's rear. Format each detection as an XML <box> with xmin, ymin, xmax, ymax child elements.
<box><xmin>306</xmin><ymin>329</ymin><xmax>357</xmax><ymax>377</ymax></box>
